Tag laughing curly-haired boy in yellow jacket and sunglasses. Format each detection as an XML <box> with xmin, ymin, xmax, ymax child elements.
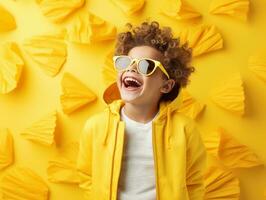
<box><xmin>77</xmin><ymin>22</ymin><xmax>206</xmax><ymax>200</ymax></box>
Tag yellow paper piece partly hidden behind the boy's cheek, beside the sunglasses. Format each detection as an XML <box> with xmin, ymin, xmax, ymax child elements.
<box><xmin>102</xmin><ymin>51</ymin><xmax>117</xmax><ymax>86</ymax></box>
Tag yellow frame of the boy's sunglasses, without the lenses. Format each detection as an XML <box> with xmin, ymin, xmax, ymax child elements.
<box><xmin>113</xmin><ymin>55</ymin><xmax>170</xmax><ymax>79</ymax></box>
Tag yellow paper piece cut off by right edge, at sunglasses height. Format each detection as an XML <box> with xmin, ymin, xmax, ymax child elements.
<box><xmin>248</xmin><ymin>56</ymin><xmax>266</xmax><ymax>83</ymax></box>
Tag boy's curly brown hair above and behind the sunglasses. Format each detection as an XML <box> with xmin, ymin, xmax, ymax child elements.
<box><xmin>115</xmin><ymin>21</ymin><xmax>195</xmax><ymax>101</ymax></box>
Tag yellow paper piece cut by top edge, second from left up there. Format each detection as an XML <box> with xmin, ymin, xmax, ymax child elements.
<box><xmin>111</xmin><ymin>0</ymin><xmax>145</xmax><ymax>16</ymax></box>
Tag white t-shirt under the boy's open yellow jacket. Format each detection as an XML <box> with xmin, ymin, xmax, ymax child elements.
<box><xmin>118</xmin><ymin>108</ymin><xmax>156</xmax><ymax>200</ymax></box>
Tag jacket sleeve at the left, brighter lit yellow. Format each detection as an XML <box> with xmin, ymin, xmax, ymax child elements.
<box><xmin>77</xmin><ymin>120</ymin><xmax>93</xmax><ymax>200</ymax></box>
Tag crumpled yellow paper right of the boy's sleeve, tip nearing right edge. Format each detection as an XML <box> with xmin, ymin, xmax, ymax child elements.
<box><xmin>204</xmin><ymin>127</ymin><xmax>263</xmax><ymax>169</ymax></box>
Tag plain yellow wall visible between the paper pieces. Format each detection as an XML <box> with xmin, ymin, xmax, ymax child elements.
<box><xmin>0</xmin><ymin>0</ymin><xmax>266</xmax><ymax>200</ymax></box>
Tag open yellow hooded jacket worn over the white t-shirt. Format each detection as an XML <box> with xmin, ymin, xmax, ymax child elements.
<box><xmin>77</xmin><ymin>85</ymin><xmax>206</xmax><ymax>200</ymax></box>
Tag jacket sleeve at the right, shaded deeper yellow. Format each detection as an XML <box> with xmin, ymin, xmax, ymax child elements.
<box><xmin>186</xmin><ymin>120</ymin><xmax>207</xmax><ymax>200</ymax></box>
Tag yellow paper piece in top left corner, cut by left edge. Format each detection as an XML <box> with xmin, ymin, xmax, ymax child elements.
<box><xmin>0</xmin><ymin>5</ymin><xmax>17</xmax><ymax>32</ymax></box>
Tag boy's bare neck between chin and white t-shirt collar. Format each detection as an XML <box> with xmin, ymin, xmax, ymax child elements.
<box><xmin>124</xmin><ymin>103</ymin><xmax>159</xmax><ymax>123</ymax></box>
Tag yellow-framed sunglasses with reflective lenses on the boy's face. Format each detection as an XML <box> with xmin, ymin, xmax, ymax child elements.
<box><xmin>113</xmin><ymin>55</ymin><xmax>170</xmax><ymax>79</ymax></box>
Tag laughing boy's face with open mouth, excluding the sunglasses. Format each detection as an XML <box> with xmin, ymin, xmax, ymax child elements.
<box><xmin>117</xmin><ymin>46</ymin><xmax>172</xmax><ymax>105</ymax></box>
